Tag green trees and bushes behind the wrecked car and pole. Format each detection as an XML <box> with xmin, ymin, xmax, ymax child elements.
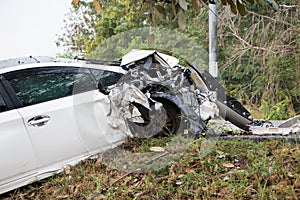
<box><xmin>57</xmin><ymin>0</ymin><xmax>300</xmax><ymax>119</ymax></box>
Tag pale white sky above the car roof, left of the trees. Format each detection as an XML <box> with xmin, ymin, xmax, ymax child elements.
<box><xmin>0</xmin><ymin>0</ymin><xmax>72</xmax><ymax>60</ymax></box>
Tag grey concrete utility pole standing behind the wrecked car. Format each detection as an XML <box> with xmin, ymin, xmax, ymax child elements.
<box><xmin>208</xmin><ymin>0</ymin><xmax>218</xmax><ymax>78</ymax></box>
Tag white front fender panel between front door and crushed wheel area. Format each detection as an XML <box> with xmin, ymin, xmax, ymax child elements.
<box><xmin>74</xmin><ymin>91</ymin><xmax>129</xmax><ymax>151</ymax></box>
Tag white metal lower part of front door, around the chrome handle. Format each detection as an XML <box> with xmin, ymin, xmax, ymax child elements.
<box><xmin>18</xmin><ymin>96</ymin><xmax>86</xmax><ymax>168</ymax></box>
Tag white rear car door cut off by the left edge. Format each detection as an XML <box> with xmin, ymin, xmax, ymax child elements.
<box><xmin>0</xmin><ymin>79</ymin><xmax>36</xmax><ymax>188</ymax></box>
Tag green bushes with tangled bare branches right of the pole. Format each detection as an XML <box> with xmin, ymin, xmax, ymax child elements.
<box><xmin>220</xmin><ymin>1</ymin><xmax>300</xmax><ymax>119</ymax></box>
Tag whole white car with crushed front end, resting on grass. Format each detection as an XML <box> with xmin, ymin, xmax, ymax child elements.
<box><xmin>0</xmin><ymin>51</ymin><xmax>299</xmax><ymax>194</ymax></box>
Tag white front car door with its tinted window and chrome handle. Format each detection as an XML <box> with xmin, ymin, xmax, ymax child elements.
<box><xmin>4</xmin><ymin>66</ymin><xmax>92</xmax><ymax>170</ymax></box>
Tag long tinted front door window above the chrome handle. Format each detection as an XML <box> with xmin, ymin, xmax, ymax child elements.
<box><xmin>4</xmin><ymin>67</ymin><xmax>96</xmax><ymax>106</ymax></box>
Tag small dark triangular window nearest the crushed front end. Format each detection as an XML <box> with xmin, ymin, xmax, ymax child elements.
<box><xmin>91</xmin><ymin>69</ymin><xmax>123</xmax><ymax>87</ymax></box>
